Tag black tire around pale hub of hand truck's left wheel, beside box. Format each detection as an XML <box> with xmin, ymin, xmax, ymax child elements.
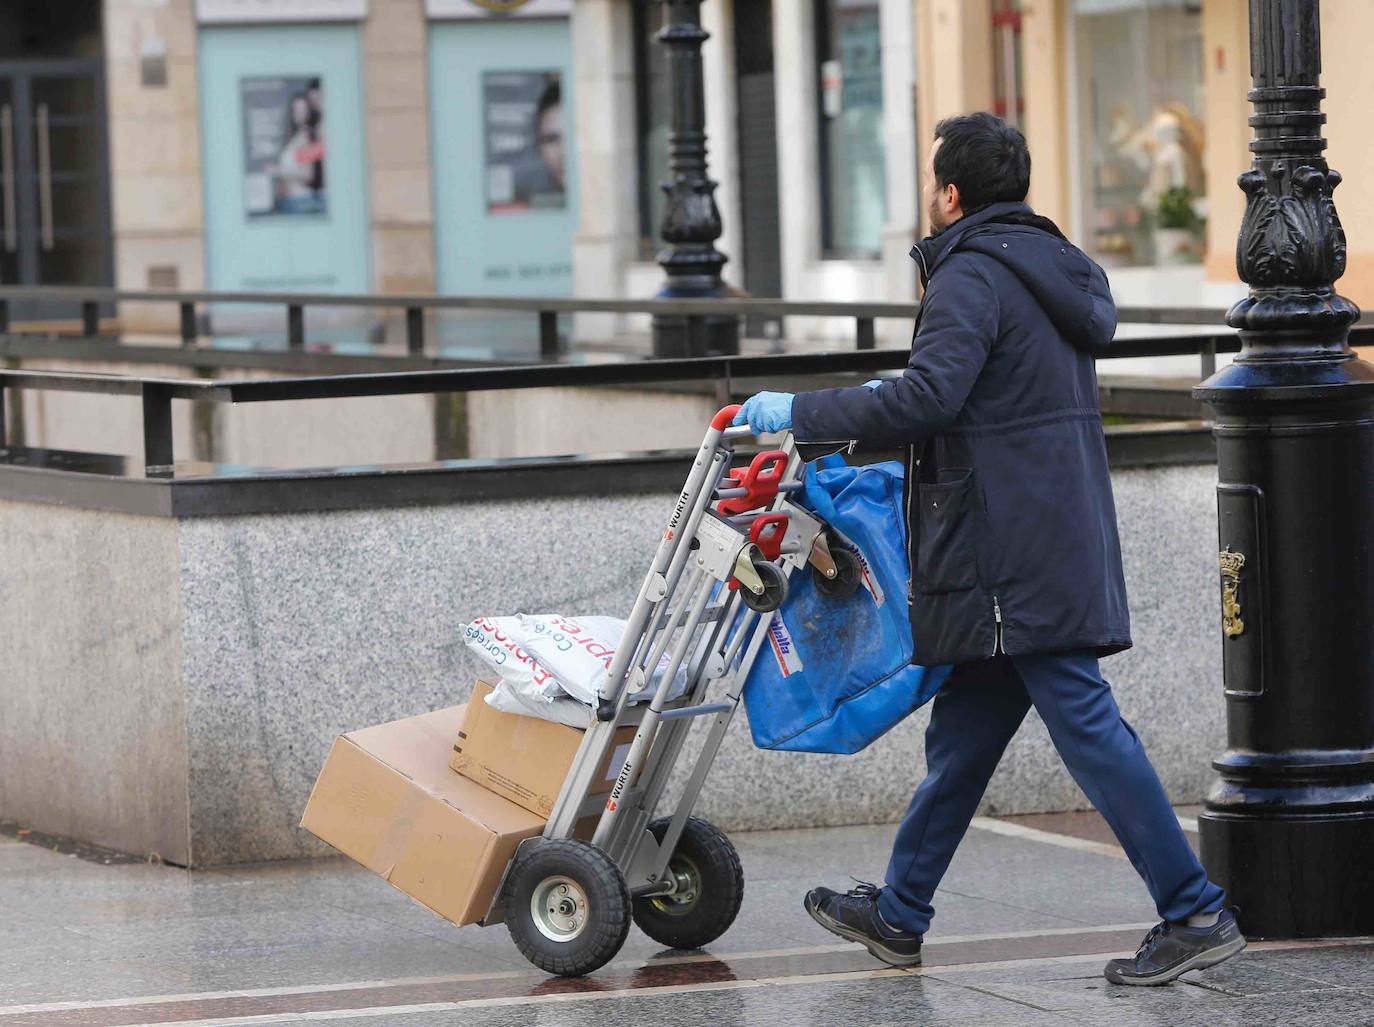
<box><xmin>502</xmin><ymin>839</ymin><xmax>631</xmax><ymax>978</ymax></box>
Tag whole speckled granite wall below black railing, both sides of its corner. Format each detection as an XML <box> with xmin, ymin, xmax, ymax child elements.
<box><xmin>0</xmin><ymin>466</ymin><xmax>1224</xmax><ymax>863</ymax></box>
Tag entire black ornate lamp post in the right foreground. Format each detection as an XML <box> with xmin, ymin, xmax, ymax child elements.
<box><xmin>1194</xmin><ymin>0</ymin><xmax>1374</xmax><ymax>938</ymax></box>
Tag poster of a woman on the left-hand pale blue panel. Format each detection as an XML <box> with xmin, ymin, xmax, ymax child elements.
<box><xmin>239</xmin><ymin>76</ymin><xmax>328</xmax><ymax>217</ymax></box>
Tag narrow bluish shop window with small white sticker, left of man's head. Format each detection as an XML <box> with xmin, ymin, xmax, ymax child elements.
<box><xmin>816</xmin><ymin>0</ymin><xmax>888</xmax><ymax>258</ymax></box>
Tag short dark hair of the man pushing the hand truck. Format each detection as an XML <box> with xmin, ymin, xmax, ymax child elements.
<box><xmin>936</xmin><ymin>111</ymin><xmax>1031</xmax><ymax>214</ymax></box>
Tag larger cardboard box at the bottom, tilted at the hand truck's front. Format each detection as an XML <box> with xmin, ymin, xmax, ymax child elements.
<box><xmin>301</xmin><ymin>704</ymin><xmax>544</xmax><ymax>927</ymax></box>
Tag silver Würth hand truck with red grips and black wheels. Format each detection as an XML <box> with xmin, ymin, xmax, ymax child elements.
<box><xmin>482</xmin><ymin>406</ymin><xmax>859</xmax><ymax>976</ymax></box>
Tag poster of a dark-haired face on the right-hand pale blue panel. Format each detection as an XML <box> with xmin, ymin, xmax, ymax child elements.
<box><xmin>482</xmin><ymin>71</ymin><xmax>566</xmax><ymax>214</ymax></box>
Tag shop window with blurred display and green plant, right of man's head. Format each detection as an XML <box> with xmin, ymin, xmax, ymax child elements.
<box><xmin>1070</xmin><ymin>0</ymin><xmax>1206</xmax><ymax>267</ymax></box>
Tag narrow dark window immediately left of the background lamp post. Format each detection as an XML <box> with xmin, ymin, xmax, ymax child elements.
<box><xmin>633</xmin><ymin>0</ymin><xmax>671</xmax><ymax>260</ymax></box>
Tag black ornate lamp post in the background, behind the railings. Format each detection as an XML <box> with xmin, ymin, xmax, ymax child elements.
<box><xmin>654</xmin><ymin>0</ymin><xmax>739</xmax><ymax>356</ymax></box>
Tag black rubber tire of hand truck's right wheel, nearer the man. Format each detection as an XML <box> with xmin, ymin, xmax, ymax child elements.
<box><xmin>635</xmin><ymin>817</ymin><xmax>745</xmax><ymax>949</ymax></box>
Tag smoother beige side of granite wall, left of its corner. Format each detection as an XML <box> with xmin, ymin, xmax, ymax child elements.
<box><xmin>0</xmin><ymin>502</ymin><xmax>191</xmax><ymax>863</ymax></box>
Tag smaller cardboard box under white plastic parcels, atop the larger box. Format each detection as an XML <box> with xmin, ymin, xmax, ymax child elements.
<box><xmin>449</xmin><ymin>681</ymin><xmax>636</xmax><ymax>818</ymax></box>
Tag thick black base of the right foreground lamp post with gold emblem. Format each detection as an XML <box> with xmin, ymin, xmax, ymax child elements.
<box><xmin>1194</xmin><ymin>362</ymin><xmax>1374</xmax><ymax>938</ymax></box>
